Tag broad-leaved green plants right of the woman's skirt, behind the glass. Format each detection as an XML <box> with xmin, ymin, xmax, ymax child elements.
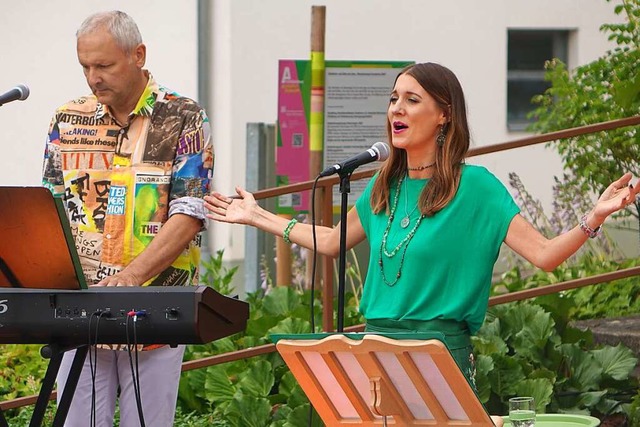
<box><xmin>473</xmin><ymin>302</ymin><xmax>637</xmax><ymax>415</ymax></box>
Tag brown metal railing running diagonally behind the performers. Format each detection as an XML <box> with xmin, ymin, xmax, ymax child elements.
<box><xmin>0</xmin><ymin>116</ymin><xmax>640</xmax><ymax>411</ymax></box>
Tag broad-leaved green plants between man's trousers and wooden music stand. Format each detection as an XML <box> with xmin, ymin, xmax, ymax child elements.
<box><xmin>179</xmin><ymin>287</ymin><xmax>330</xmax><ymax>427</ymax></box>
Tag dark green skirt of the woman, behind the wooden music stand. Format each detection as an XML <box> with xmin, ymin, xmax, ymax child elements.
<box><xmin>364</xmin><ymin>319</ymin><xmax>476</xmax><ymax>390</ymax></box>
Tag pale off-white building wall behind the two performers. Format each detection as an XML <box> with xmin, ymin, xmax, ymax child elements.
<box><xmin>0</xmin><ymin>0</ymin><xmax>620</xmax><ymax>260</ymax></box>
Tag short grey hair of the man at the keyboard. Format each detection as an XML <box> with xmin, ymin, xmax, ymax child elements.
<box><xmin>76</xmin><ymin>10</ymin><xmax>142</xmax><ymax>52</ymax></box>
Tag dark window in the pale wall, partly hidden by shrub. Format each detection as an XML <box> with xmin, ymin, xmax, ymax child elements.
<box><xmin>507</xmin><ymin>30</ymin><xmax>569</xmax><ymax>131</ymax></box>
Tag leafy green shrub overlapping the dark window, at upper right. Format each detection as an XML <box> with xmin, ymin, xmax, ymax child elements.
<box><xmin>531</xmin><ymin>0</ymin><xmax>640</xmax><ymax>227</ymax></box>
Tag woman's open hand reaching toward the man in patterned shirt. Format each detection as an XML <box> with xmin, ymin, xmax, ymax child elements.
<box><xmin>204</xmin><ymin>187</ymin><xmax>258</xmax><ymax>225</ymax></box>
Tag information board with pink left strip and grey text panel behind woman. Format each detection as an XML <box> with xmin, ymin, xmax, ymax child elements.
<box><xmin>276</xmin><ymin>60</ymin><xmax>413</xmax><ymax>215</ymax></box>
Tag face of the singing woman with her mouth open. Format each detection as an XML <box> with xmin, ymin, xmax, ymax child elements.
<box><xmin>387</xmin><ymin>74</ymin><xmax>446</xmax><ymax>153</ymax></box>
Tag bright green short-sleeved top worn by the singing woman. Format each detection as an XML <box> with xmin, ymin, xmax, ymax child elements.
<box><xmin>356</xmin><ymin>165</ymin><xmax>519</xmax><ymax>334</ymax></box>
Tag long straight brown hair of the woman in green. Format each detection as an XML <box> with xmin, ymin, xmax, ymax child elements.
<box><xmin>371</xmin><ymin>62</ymin><xmax>470</xmax><ymax>216</ymax></box>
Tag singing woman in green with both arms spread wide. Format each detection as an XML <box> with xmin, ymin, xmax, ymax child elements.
<box><xmin>205</xmin><ymin>63</ymin><xmax>638</xmax><ymax>384</ymax></box>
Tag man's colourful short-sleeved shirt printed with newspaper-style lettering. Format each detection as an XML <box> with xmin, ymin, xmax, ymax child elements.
<box><xmin>43</xmin><ymin>75</ymin><xmax>213</xmax><ymax>286</ymax></box>
